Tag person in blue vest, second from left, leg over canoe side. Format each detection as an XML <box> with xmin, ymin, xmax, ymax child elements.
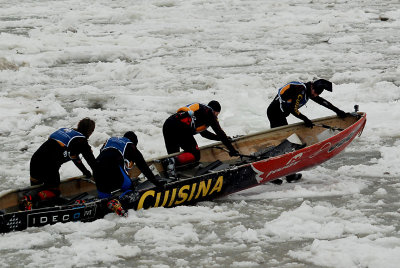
<box><xmin>93</xmin><ymin>131</ymin><xmax>164</xmax><ymax>216</ymax></box>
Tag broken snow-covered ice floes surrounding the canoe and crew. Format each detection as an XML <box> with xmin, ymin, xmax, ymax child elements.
<box><xmin>0</xmin><ymin>0</ymin><xmax>400</xmax><ymax>268</ymax></box>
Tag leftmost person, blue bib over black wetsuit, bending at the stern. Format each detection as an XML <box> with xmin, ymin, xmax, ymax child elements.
<box><xmin>21</xmin><ymin>118</ymin><xmax>95</xmax><ymax>210</ymax></box>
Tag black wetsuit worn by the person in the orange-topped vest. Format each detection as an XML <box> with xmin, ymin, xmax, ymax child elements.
<box><xmin>163</xmin><ymin>104</ymin><xmax>236</xmax><ymax>161</ymax></box>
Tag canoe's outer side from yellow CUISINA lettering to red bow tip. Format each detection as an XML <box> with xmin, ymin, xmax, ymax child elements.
<box><xmin>126</xmin><ymin>112</ymin><xmax>366</xmax><ymax>210</ymax></box>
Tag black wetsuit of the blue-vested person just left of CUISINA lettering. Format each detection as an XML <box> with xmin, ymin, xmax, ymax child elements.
<box><xmin>93</xmin><ymin>139</ymin><xmax>162</xmax><ymax>194</ymax></box>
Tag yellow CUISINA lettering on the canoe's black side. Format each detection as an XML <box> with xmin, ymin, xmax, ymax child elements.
<box><xmin>137</xmin><ymin>176</ymin><xmax>224</xmax><ymax>210</ymax></box>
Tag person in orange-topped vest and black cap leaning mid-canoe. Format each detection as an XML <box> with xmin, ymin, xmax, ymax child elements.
<box><xmin>163</xmin><ymin>100</ymin><xmax>239</xmax><ymax>177</ymax></box>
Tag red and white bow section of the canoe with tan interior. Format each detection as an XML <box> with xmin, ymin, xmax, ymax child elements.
<box><xmin>248</xmin><ymin>113</ymin><xmax>366</xmax><ymax>183</ymax></box>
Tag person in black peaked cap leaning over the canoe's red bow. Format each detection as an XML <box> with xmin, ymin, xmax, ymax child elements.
<box><xmin>267</xmin><ymin>79</ymin><xmax>346</xmax><ymax>184</ymax></box>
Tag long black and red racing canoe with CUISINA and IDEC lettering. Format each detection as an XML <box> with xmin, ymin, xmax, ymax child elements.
<box><xmin>0</xmin><ymin>113</ymin><xmax>366</xmax><ymax>233</ymax></box>
